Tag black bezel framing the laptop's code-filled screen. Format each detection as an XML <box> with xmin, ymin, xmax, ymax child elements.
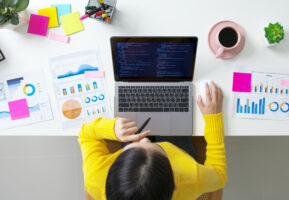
<box><xmin>110</xmin><ymin>36</ymin><xmax>198</xmax><ymax>82</ymax></box>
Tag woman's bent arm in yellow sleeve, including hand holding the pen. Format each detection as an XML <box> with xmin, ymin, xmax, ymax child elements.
<box><xmin>78</xmin><ymin>118</ymin><xmax>150</xmax><ymax>191</ymax></box>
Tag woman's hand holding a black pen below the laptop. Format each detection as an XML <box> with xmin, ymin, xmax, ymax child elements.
<box><xmin>114</xmin><ymin>118</ymin><xmax>151</xmax><ymax>142</ymax></box>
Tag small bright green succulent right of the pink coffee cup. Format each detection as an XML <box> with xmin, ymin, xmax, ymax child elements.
<box><xmin>264</xmin><ymin>22</ymin><xmax>284</xmax><ymax>44</ymax></box>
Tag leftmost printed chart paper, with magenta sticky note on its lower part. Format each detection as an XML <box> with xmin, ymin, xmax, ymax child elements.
<box><xmin>0</xmin><ymin>71</ymin><xmax>52</xmax><ymax>129</ymax></box>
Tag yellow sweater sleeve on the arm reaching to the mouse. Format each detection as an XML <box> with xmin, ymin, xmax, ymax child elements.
<box><xmin>198</xmin><ymin>113</ymin><xmax>227</xmax><ymax>193</ymax></box>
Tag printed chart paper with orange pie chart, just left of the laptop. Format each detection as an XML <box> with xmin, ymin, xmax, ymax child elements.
<box><xmin>49</xmin><ymin>50</ymin><xmax>113</xmax><ymax>128</ymax></box>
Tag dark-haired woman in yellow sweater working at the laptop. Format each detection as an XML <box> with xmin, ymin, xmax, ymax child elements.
<box><xmin>79</xmin><ymin>83</ymin><xmax>227</xmax><ymax>200</ymax></box>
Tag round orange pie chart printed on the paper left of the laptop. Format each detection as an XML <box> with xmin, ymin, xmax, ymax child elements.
<box><xmin>62</xmin><ymin>99</ymin><xmax>82</xmax><ymax>119</ymax></box>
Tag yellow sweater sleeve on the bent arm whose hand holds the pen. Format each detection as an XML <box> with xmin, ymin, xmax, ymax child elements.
<box><xmin>78</xmin><ymin>118</ymin><xmax>118</xmax><ymax>190</ymax></box>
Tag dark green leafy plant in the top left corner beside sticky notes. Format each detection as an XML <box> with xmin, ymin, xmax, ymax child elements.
<box><xmin>0</xmin><ymin>0</ymin><xmax>29</xmax><ymax>25</ymax></box>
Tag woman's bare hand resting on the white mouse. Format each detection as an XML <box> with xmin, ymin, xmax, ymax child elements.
<box><xmin>197</xmin><ymin>81</ymin><xmax>223</xmax><ymax>115</ymax></box>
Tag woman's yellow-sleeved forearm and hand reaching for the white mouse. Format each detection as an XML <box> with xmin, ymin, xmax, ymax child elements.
<box><xmin>198</xmin><ymin>83</ymin><xmax>227</xmax><ymax>193</ymax></box>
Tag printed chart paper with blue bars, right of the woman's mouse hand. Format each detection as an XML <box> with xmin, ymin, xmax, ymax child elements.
<box><xmin>233</xmin><ymin>65</ymin><xmax>289</xmax><ymax>120</ymax></box>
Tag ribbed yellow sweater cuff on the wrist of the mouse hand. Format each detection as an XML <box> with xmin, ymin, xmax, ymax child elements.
<box><xmin>203</xmin><ymin>113</ymin><xmax>224</xmax><ymax>144</ymax></box>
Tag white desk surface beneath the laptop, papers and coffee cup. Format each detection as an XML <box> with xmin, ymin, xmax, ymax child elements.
<box><xmin>0</xmin><ymin>0</ymin><xmax>289</xmax><ymax>136</ymax></box>
